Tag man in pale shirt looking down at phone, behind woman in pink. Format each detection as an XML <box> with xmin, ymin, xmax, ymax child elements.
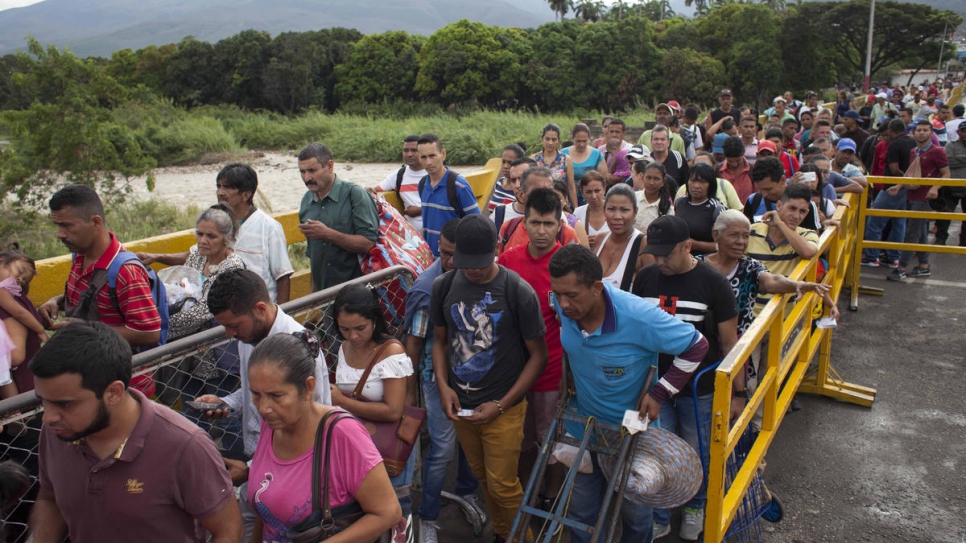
<box><xmin>195</xmin><ymin>270</ymin><xmax>332</xmax><ymax>541</ymax></box>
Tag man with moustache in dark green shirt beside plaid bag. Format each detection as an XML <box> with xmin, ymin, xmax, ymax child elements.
<box><xmin>298</xmin><ymin>143</ymin><xmax>382</xmax><ymax>292</ymax></box>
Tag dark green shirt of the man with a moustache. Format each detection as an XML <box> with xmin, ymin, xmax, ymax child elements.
<box><xmin>299</xmin><ymin>177</ymin><xmax>379</xmax><ymax>290</ymax></box>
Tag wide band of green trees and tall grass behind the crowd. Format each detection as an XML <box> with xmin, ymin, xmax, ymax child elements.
<box><xmin>0</xmin><ymin>0</ymin><xmax>962</xmax><ymax>208</ymax></box>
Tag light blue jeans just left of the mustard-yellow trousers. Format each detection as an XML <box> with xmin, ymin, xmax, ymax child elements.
<box><xmin>419</xmin><ymin>379</ymin><xmax>480</xmax><ymax>520</ymax></box>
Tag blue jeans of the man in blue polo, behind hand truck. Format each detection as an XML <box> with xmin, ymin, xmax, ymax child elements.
<box><xmin>567</xmin><ymin>454</ymin><xmax>654</xmax><ymax>543</ymax></box>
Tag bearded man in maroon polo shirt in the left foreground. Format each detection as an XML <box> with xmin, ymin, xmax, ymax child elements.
<box><xmin>30</xmin><ymin>321</ymin><xmax>242</xmax><ymax>543</ymax></box>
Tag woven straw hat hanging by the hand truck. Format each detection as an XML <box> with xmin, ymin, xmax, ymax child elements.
<box><xmin>598</xmin><ymin>426</ymin><xmax>704</xmax><ymax>509</ymax></box>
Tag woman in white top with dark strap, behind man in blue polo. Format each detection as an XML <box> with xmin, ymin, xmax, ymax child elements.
<box><xmin>596</xmin><ymin>183</ymin><xmax>654</xmax><ymax>292</ymax></box>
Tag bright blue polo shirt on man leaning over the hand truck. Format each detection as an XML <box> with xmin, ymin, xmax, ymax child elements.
<box><xmin>551</xmin><ymin>283</ymin><xmax>701</xmax><ymax>439</ymax></box>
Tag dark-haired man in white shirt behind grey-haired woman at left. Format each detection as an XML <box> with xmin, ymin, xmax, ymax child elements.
<box><xmin>137</xmin><ymin>162</ymin><xmax>294</xmax><ymax>304</ymax></box>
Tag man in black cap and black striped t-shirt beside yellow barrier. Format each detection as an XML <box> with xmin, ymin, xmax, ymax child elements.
<box><xmin>631</xmin><ymin>215</ymin><xmax>736</xmax><ymax>541</ymax></box>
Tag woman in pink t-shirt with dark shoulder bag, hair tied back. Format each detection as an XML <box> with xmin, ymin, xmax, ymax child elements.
<box><xmin>250</xmin><ymin>332</ymin><xmax>402</xmax><ymax>543</ymax></box>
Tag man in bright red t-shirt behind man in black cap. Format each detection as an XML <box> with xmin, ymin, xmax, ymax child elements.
<box><xmin>497</xmin><ymin>188</ymin><xmax>564</xmax><ymax>506</ymax></box>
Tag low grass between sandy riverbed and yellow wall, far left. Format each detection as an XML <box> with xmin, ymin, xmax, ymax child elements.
<box><xmin>0</xmin><ymin>198</ymin><xmax>201</xmax><ymax>260</ymax></box>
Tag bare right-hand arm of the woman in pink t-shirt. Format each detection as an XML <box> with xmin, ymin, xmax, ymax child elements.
<box><xmin>326</xmin><ymin>463</ymin><xmax>402</xmax><ymax>543</ymax></box>
